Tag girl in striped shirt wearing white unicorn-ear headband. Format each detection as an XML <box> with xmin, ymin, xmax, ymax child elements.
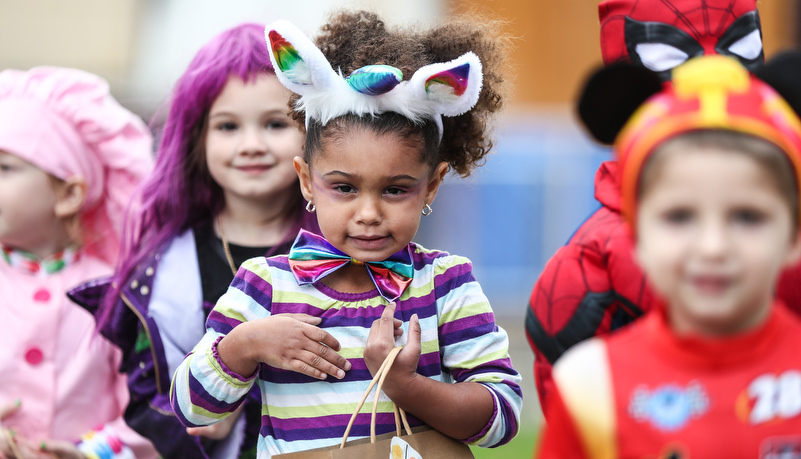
<box><xmin>170</xmin><ymin>12</ymin><xmax>522</xmax><ymax>457</ymax></box>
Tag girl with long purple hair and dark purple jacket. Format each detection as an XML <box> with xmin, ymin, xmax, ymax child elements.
<box><xmin>72</xmin><ymin>24</ymin><xmax>317</xmax><ymax>458</ymax></box>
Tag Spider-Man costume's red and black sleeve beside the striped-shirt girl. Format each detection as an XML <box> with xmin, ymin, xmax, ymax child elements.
<box><xmin>526</xmin><ymin>207</ymin><xmax>652</xmax><ymax>417</ymax></box>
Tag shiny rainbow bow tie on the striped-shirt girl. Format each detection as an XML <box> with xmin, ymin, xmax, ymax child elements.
<box><xmin>289</xmin><ymin>229</ymin><xmax>414</xmax><ymax>301</ymax></box>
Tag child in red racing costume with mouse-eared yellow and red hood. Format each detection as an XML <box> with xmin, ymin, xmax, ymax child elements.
<box><xmin>539</xmin><ymin>54</ymin><xmax>801</xmax><ymax>459</ymax></box>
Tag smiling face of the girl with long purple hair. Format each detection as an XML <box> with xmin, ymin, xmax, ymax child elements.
<box><xmin>205</xmin><ymin>74</ymin><xmax>303</xmax><ymax>208</ymax></box>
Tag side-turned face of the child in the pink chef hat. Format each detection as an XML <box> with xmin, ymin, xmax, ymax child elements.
<box><xmin>0</xmin><ymin>151</ymin><xmax>61</xmax><ymax>252</ymax></box>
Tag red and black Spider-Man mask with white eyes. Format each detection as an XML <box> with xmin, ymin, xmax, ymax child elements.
<box><xmin>598</xmin><ymin>0</ymin><xmax>765</xmax><ymax>79</ymax></box>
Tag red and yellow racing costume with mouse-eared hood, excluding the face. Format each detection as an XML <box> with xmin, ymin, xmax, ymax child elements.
<box><xmin>537</xmin><ymin>52</ymin><xmax>801</xmax><ymax>459</ymax></box>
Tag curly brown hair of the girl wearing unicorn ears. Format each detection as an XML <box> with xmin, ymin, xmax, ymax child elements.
<box><xmin>290</xmin><ymin>11</ymin><xmax>511</xmax><ymax>177</ymax></box>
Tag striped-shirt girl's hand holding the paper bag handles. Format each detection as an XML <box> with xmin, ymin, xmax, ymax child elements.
<box><xmin>364</xmin><ymin>302</ymin><xmax>412</xmax><ymax>384</ymax></box>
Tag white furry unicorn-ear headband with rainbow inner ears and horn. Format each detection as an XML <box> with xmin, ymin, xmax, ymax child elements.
<box><xmin>264</xmin><ymin>20</ymin><xmax>482</xmax><ymax>139</ymax></box>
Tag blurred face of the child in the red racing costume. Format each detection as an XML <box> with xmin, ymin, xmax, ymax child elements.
<box><xmin>636</xmin><ymin>147</ymin><xmax>800</xmax><ymax>336</ymax></box>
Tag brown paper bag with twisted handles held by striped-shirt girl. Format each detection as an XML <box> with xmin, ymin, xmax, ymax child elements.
<box><xmin>273</xmin><ymin>347</ymin><xmax>475</xmax><ymax>459</ymax></box>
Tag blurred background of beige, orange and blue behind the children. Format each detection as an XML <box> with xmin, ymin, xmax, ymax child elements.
<box><xmin>0</xmin><ymin>0</ymin><xmax>801</xmax><ymax>458</ymax></box>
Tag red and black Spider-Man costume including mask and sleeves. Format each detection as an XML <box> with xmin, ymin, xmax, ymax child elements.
<box><xmin>526</xmin><ymin>0</ymin><xmax>788</xmax><ymax>416</ymax></box>
